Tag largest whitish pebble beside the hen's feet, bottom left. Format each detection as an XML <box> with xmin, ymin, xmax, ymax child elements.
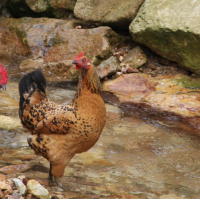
<box><xmin>27</xmin><ymin>179</ymin><xmax>51</xmax><ymax>199</ymax></box>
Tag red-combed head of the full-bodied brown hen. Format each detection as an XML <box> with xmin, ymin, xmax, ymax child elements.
<box><xmin>72</xmin><ymin>52</ymin><xmax>91</xmax><ymax>69</ymax></box>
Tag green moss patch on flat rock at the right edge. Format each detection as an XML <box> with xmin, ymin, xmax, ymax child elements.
<box><xmin>177</xmin><ymin>76</ymin><xmax>200</xmax><ymax>89</ymax></box>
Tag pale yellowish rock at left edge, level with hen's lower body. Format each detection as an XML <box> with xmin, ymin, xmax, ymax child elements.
<box><xmin>0</xmin><ymin>115</ymin><xmax>22</xmax><ymax>130</ymax></box>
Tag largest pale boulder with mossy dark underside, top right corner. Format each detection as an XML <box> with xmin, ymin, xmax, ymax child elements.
<box><xmin>129</xmin><ymin>0</ymin><xmax>200</xmax><ymax>74</ymax></box>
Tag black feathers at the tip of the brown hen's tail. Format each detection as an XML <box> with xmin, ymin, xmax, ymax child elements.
<box><xmin>19</xmin><ymin>69</ymin><xmax>46</xmax><ymax>107</ymax></box>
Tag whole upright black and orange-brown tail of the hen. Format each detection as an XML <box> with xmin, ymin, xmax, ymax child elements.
<box><xmin>19</xmin><ymin>69</ymin><xmax>46</xmax><ymax>126</ymax></box>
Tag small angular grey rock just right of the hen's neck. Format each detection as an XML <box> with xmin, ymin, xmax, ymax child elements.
<box><xmin>96</xmin><ymin>56</ymin><xmax>121</xmax><ymax>79</ymax></box>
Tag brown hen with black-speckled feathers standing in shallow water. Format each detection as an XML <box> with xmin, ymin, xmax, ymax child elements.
<box><xmin>19</xmin><ymin>52</ymin><xmax>106</xmax><ymax>185</ymax></box>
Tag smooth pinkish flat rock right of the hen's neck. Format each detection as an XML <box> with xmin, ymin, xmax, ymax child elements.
<box><xmin>102</xmin><ymin>74</ymin><xmax>155</xmax><ymax>99</ymax></box>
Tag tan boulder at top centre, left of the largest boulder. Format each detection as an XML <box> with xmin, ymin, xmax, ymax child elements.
<box><xmin>74</xmin><ymin>0</ymin><xmax>144</xmax><ymax>28</ymax></box>
